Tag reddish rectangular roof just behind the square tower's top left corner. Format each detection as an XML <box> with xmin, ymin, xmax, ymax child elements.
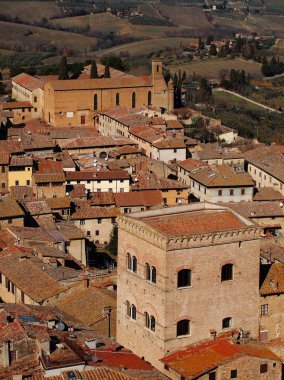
<box><xmin>114</xmin><ymin>190</ymin><xmax>163</xmax><ymax>207</ymax></box>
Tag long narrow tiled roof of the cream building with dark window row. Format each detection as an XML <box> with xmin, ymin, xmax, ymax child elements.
<box><xmin>66</xmin><ymin>170</ymin><xmax>130</xmax><ymax>181</ymax></box>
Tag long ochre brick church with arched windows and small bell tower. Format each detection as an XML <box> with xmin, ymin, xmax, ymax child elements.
<box><xmin>43</xmin><ymin>60</ymin><xmax>174</xmax><ymax>127</ymax></box>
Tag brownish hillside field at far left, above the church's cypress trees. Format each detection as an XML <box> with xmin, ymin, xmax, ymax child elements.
<box><xmin>0</xmin><ymin>21</ymin><xmax>97</xmax><ymax>52</ymax></box>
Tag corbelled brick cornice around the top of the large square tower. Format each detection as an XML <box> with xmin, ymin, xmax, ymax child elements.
<box><xmin>118</xmin><ymin>216</ymin><xmax>262</xmax><ymax>251</ymax></box>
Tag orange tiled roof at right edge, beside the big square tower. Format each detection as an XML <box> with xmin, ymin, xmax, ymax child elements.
<box><xmin>260</xmin><ymin>263</ymin><xmax>284</xmax><ymax>296</ymax></box>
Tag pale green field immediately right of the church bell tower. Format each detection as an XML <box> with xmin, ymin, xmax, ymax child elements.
<box><xmin>167</xmin><ymin>58</ymin><xmax>262</xmax><ymax>79</ymax></box>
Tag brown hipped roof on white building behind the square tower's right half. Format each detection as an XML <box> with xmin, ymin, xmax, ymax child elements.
<box><xmin>188</xmin><ymin>165</ymin><xmax>254</xmax><ymax>187</ymax></box>
